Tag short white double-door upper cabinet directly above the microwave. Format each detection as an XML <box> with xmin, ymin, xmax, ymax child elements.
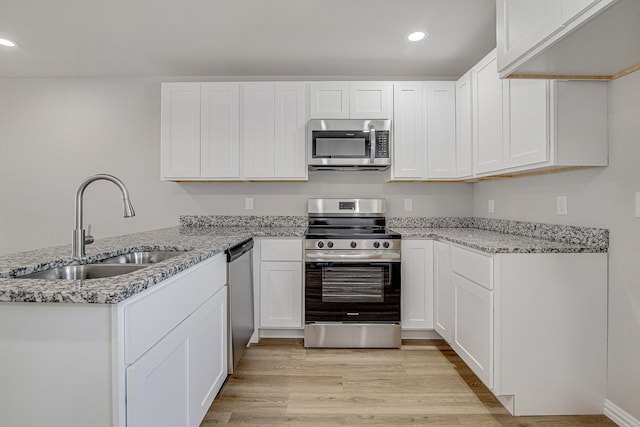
<box><xmin>310</xmin><ymin>82</ymin><xmax>391</xmax><ymax>119</ymax></box>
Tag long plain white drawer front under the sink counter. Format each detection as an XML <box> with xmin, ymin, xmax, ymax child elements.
<box><xmin>124</xmin><ymin>254</ymin><xmax>227</xmax><ymax>364</ymax></box>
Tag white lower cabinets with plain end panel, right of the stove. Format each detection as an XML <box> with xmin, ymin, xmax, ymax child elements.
<box><xmin>434</xmin><ymin>242</ymin><xmax>607</xmax><ymax>415</ymax></box>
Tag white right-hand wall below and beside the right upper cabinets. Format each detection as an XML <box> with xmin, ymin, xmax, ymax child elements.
<box><xmin>474</xmin><ymin>72</ymin><xmax>640</xmax><ymax>419</ymax></box>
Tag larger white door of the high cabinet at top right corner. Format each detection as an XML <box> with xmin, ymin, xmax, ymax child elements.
<box><xmin>496</xmin><ymin>0</ymin><xmax>562</xmax><ymax>70</ymax></box>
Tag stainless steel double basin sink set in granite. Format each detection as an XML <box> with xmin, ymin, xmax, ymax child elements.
<box><xmin>16</xmin><ymin>250</ymin><xmax>185</xmax><ymax>280</ymax></box>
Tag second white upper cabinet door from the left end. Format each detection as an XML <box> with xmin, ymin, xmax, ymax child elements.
<box><xmin>201</xmin><ymin>83</ymin><xmax>240</xmax><ymax>178</ymax></box>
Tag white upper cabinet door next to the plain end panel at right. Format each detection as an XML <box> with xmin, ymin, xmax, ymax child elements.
<box><xmin>503</xmin><ymin>79</ymin><xmax>550</xmax><ymax>167</ymax></box>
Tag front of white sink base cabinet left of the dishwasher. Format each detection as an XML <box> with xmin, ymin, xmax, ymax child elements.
<box><xmin>124</xmin><ymin>254</ymin><xmax>227</xmax><ymax>427</ymax></box>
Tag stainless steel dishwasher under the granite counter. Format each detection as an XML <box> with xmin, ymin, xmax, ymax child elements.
<box><xmin>226</xmin><ymin>239</ymin><xmax>254</xmax><ymax>374</ymax></box>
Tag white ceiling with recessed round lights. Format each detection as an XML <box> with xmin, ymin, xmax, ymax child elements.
<box><xmin>0</xmin><ymin>0</ymin><xmax>495</xmax><ymax>78</ymax></box>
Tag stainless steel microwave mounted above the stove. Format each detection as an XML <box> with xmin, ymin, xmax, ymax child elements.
<box><xmin>307</xmin><ymin>119</ymin><xmax>391</xmax><ymax>170</ymax></box>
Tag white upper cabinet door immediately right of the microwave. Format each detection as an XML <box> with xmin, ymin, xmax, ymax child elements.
<box><xmin>392</xmin><ymin>83</ymin><xmax>424</xmax><ymax>179</ymax></box>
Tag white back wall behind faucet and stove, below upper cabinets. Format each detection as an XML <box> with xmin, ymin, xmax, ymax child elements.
<box><xmin>0</xmin><ymin>78</ymin><xmax>473</xmax><ymax>254</ymax></box>
